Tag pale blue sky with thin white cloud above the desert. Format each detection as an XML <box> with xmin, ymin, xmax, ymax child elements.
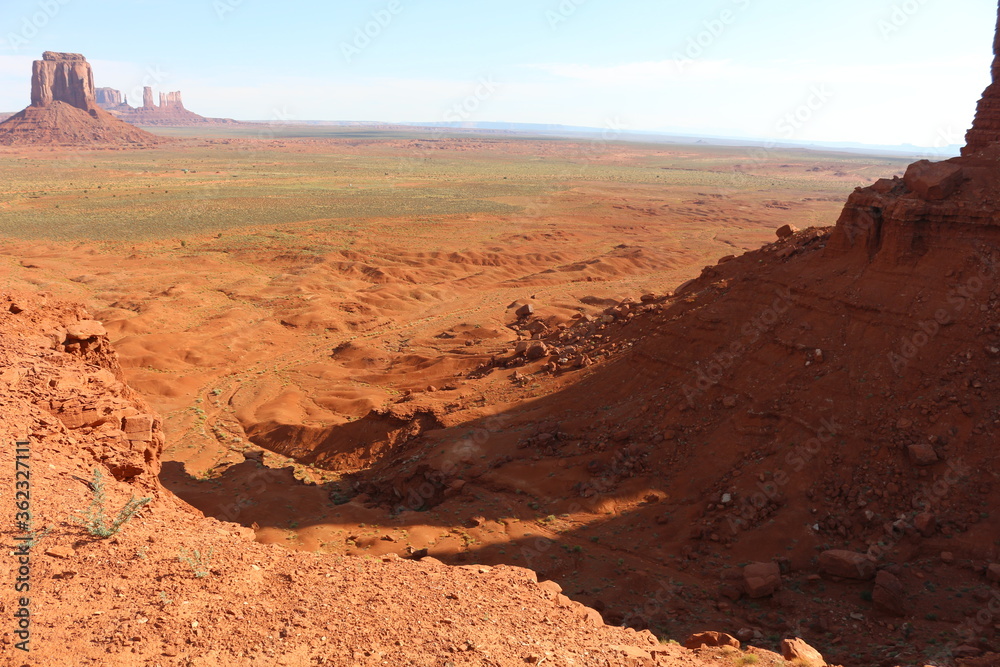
<box><xmin>0</xmin><ymin>0</ymin><xmax>996</xmax><ymax>146</ymax></box>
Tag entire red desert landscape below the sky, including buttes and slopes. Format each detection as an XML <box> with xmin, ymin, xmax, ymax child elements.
<box><xmin>0</xmin><ymin>2</ymin><xmax>1000</xmax><ymax>667</ymax></box>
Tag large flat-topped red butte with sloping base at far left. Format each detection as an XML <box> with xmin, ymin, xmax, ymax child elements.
<box><xmin>0</xmin><ymin>51</ymin><xmax>161</xmax><ymax>146</ymax></box>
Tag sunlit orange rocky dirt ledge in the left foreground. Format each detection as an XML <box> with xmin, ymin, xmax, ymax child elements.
<box><xmin>0</xmin><ymin>296</ymin><xmax>800</xmax><ymax>666</ymax></box>
